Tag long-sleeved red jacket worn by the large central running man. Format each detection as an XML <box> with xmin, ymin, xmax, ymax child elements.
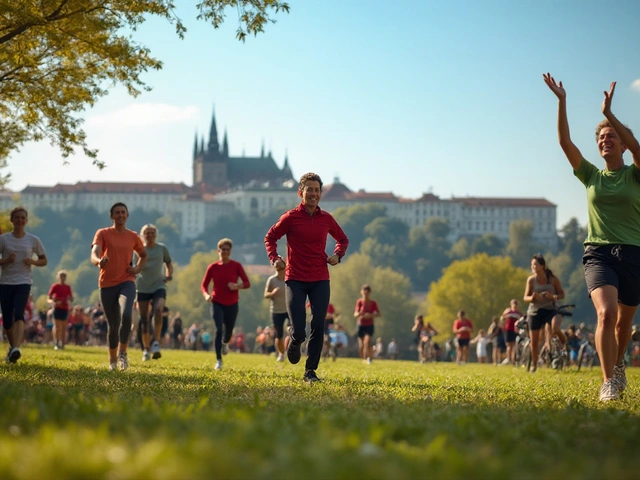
<box><xmin>264</xmin><ymin>203</ymin><xmax>349</xmax><ymax>282</ymax></box>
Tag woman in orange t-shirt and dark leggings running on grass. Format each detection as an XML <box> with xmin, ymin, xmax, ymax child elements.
<box><xmin>91</xmin><ymin>202</ymin><xmax>147</xmax><ymax>371</ymax></box>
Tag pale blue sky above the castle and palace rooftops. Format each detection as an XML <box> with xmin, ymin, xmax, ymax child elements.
<box><xmin>9</xmin><ymin>0</ymin><xmax>640</xmax><ymax>226</ymax></box>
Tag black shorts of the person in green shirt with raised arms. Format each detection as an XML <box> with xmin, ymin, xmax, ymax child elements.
<box><xmin>582</xmin><ymin>245</ymin><xmax>640</xmax><ymax>307</ymax></box>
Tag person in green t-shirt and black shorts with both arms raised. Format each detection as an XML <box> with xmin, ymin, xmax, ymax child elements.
<box><xmin>543</xmin><ymin>73</ymin><xmax>640</xmax><ymax>402</ymax></box>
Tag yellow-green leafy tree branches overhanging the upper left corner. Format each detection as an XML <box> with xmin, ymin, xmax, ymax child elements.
<box><xmin>0</xmin><ymin>0</ymin><xmax>289</xmax><ymax>167</ymax></box>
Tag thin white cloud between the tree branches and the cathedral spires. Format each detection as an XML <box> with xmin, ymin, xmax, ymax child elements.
<box><xmin>87</xmin><ymin>103</ymin><xmax>198</xmax><ymax>128</ymax></box>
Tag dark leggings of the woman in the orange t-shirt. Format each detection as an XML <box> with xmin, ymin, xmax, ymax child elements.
<box><xmin>100</xmin><ymin>282</ymin><xmax>136</xmax><ymax>349</ymax></box>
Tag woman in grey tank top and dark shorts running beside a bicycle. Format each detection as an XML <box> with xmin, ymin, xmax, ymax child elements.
<box><xmin>524</xmin><ymin>253</ymin><xmax>567</xmax><ymax>373</ymax></box>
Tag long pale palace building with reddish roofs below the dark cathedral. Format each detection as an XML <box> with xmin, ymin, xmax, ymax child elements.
<box><xmin>0</xmin><ymin>178</ymin><xmax>557</xmax><ymax>248</ymax></box>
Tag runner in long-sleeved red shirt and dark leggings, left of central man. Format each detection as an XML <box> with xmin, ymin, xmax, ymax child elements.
<box><xmin>201</xmin><ymin>238</ymin><xmax>251</xmax><ymax>370</ymax></box>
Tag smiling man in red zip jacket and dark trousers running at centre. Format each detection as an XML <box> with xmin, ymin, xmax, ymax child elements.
<box><xmin>264</xmin><ymin>173</ymin><xmax>349</xmax><ymax>383</ymax></box>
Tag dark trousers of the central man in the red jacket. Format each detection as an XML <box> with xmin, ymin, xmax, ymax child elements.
<box><xmin>285</xmin><ymin>280</ymin><xmax>331</xmax><ymax>370</ymax></box>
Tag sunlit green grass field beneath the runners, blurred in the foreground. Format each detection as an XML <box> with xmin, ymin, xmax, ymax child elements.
<box><xmin>0</xmin><ymin>347</ymin><xmax>640</xmax><ymax>480</ymax></box>
